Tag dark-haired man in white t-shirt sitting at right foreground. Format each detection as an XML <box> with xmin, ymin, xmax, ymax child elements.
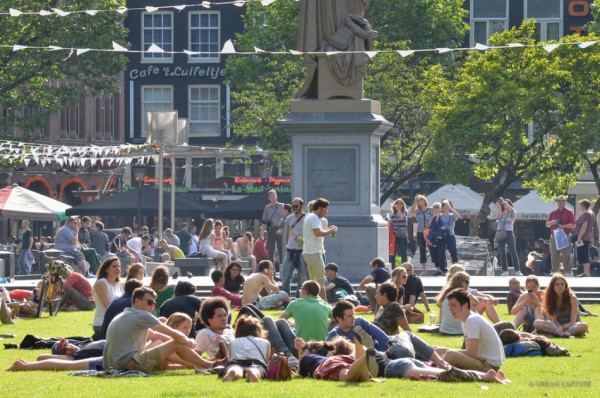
<box><xmin>445</xmin><ymin>289</ymin><xmax>506</xmax><ymax>372</ymax></box>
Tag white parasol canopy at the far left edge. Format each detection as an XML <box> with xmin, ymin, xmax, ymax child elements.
<box><xmin>0</xmin><ymin>185</ymin><xmax>71</xmax><ymax>221</ymax></box>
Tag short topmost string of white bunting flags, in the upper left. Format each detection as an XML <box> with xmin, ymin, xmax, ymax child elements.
<box><xmin>0</xmin><ymin>0</ymin><xmax>280</xmax><ymax>17</ymax></box>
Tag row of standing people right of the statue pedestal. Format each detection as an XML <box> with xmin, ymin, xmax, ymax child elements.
<box><xmin>389</xmin><ymin>195</ymin><xmax>596</xmax><ymax>277</ymax></box>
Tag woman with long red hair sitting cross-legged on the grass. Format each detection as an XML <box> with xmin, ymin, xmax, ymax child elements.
<box><xmin>533</xmin><ymin>273</ymin><xmax>588</xmax><ymax>337</ymax></box>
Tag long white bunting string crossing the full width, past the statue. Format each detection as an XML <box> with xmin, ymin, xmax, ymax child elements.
<box><xmin>0</xmin><ymin>39</ymin><xmax>598</xmax><ymax>58</ymax></box>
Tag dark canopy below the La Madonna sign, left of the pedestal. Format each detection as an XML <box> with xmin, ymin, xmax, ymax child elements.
<box><xmin>205</xmin><ymin>191</ymin><xmax>292</xmax><ymax>220</ymax></box>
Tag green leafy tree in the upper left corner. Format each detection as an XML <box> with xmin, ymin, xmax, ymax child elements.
<box><xmin>0</xmin><ymin>0</ymin><xmax>126</xmax><ymax>134</ymax></box>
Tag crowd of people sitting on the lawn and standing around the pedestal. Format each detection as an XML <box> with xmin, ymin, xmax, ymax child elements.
<box><xmin>2</xmin><ymin>192</ymin><xmax>593</xmax><ymax>383</ymax></box>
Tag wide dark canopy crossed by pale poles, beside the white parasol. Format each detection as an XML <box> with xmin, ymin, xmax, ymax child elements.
<box><xmin>67</xmin><ymin>186</ymin><xmax>211</xmax><ymax>217</ymax></box>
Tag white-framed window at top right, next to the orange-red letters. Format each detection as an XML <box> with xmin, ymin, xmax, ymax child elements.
<box><xmin>525</xmin><ymin>0</ymin><xmax>563</xmax><ymax>41</ymax></box>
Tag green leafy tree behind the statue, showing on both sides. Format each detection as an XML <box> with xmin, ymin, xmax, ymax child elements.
<box><xmin>227</xmin><ymin>0</ymin><xmax>466</xmax><ymax>202</ymax></box>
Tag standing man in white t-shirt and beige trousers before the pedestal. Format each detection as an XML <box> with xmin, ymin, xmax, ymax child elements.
<box><xmin>302</xmin><ymin>198</ymin><xmax>337</xmax><ymax>300</ymax></box>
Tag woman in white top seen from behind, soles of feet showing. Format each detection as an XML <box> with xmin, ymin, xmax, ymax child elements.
<box><xmin>221</xmin><ymin>315</ymin><xmax>271</xmax><ymax>382</ymax></box>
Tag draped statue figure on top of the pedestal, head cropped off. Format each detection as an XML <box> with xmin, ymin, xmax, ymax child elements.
<box><xmin>295</xmin><ymin>0</ymin><xmax>376</xmax><ymax>99</ymax></box>
